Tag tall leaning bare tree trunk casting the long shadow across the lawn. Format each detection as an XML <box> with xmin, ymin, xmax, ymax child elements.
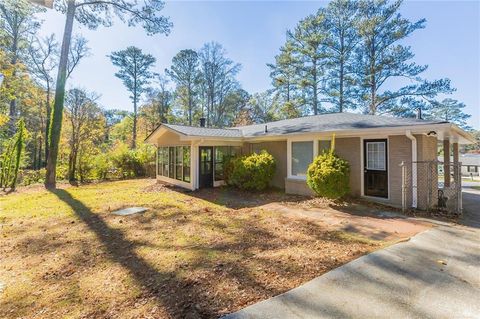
<box><xmin>45</xmin><ymin>0</ymin><xmax>75</xmax><ymax>189</ymax></box>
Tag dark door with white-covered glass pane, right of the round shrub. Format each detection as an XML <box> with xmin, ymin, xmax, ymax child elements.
<box><xmin>363</xmin><ymin>139</ymin><xmax>388</xmax><ymax>198</ymax></box>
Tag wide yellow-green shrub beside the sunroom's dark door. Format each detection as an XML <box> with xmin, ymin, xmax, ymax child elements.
<box><xmin>227</xmin><ymin>151</ymin><xmax>275</xmax><ymax>190</ymax></box>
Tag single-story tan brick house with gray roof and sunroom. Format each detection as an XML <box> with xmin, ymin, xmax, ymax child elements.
<box><xmin>146</xmin><ymin>113</ymin><xmax>473</xmax><ymax>210</ymax></box>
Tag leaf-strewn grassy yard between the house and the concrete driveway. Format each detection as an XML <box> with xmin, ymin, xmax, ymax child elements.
<box><xmin>0</xmin><ymin>179</ymin><xmax>385</xmax><ymax>318</ymax></box>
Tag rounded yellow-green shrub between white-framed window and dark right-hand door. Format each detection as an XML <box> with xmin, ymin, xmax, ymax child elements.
<box><xmin>307</xmin><ymin>149</ymin><xmax>350</xmax><ymax>199</ymax></box>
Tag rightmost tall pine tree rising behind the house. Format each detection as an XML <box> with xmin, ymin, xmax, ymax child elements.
<box><xmin>355</xmin><ymin>0</ymin><xmax>452</xmax><ymax>114</ymax></box>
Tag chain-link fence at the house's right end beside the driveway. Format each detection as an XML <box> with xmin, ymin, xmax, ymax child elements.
<box><xmin>400</xmin><ymin>161</ymin><xmax>462</xmax><ymax>216</ymax></box>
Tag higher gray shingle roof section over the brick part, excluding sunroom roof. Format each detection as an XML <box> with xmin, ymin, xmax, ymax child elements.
<box><xmin>236</xmin><ymin>113</ymin><xmax>446</xmax><ymax>137</ymax></box>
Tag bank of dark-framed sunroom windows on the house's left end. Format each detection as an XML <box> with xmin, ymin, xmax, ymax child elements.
<box><xmin>157</xmin><ymin>146</ymin><xmax>190</xmax><ymax>183</ymax></box>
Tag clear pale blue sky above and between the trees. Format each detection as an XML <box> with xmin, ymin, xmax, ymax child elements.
<box><xmin>41</xmin><ymin>1</ymin><xmax>480</xmax><ymax>129</ymax></box>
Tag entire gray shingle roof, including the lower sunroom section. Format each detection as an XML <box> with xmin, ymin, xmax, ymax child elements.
<box><xmin>153</xmin><ymin>113</ymin><xmax>447</xmax><ymax>138</ymax></box>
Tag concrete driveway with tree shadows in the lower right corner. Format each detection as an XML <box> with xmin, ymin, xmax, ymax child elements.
<box><xmin>226</xmin><ymin>189</ymin><xmax>480</xmax><ymax>319</ymax></box>
